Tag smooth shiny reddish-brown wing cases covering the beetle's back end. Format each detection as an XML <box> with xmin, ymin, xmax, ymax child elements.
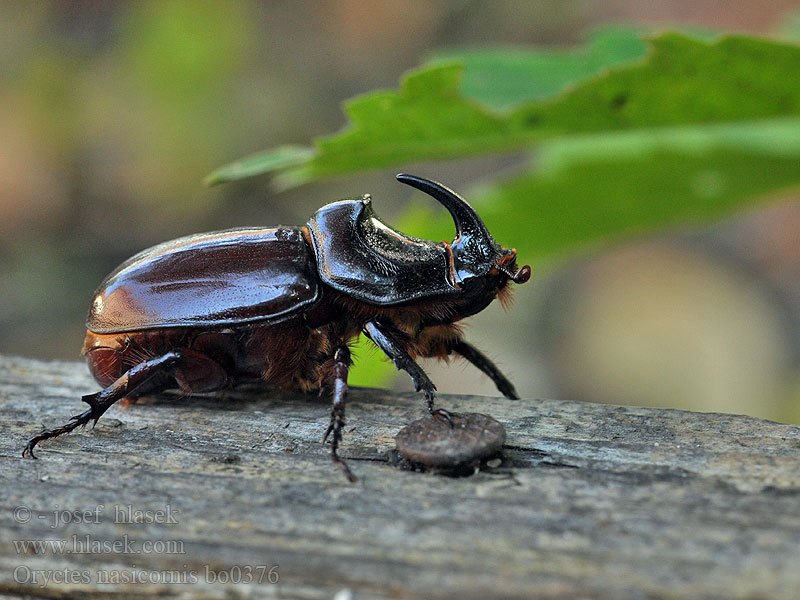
<box><xmin>86</xmin><ymin>227</ymin><xmax>319</xmax><ymax>334</ymax></box>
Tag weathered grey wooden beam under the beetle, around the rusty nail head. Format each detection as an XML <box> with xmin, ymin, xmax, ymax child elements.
<box><xmin>0</xmin><ymin>357</ymin><xmax>800</xmax><ymax>600</ymax></box>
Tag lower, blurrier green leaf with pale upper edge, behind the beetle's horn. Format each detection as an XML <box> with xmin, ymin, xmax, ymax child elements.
<box><xmin>398</xmin><ymin>118</ymin><xmax>800</xmax><ymax>262</ymax></box>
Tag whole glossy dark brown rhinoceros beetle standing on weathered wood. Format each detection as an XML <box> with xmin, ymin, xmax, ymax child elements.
<box><xmin>23</xmin><ymin>174</ymin><xmax>531</xmax><ymax>480</ymax></box>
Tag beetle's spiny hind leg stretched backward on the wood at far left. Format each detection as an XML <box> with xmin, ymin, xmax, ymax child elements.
<box><xmin>22</xmin><ymin>350</ymin><xmax>182</xmax><ymax>458</ymax></box>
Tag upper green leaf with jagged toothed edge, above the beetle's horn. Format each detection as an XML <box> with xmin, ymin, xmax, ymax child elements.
<box><xmin>208</xmin><ymin>33</ymin><xmax>800</xmax><ymax>186</ymax></box>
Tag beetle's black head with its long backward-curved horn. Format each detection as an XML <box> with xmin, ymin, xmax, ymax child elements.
<box><xmin>397</xmin><ymin>173</ymin><xmax>531</xmax><ymax>310</ymax></box>
